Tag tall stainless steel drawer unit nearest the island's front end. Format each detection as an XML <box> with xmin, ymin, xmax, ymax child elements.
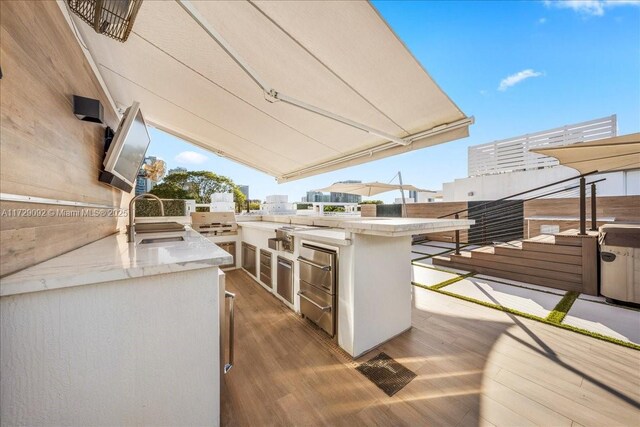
<box><xmin>298</xmin><ymin>243</ymin><xmax>338</xmax><ymax>337</ymax></box>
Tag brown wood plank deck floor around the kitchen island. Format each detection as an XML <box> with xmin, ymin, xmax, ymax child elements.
<box><xmin>222</xmin><ymin>271</ymin><xmax>640</xmax><ymax>426</ymax></box>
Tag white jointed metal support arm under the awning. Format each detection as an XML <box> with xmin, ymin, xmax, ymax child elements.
<box><xmin>175</xmin><ymin>0</ymin><xmax>412</xmax><ymax>145</ymax></box>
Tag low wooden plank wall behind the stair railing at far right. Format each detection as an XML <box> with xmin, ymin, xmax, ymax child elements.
<box><xmin>524</xmin><ymin>196</ymin><xmax>640</xmax><ymax>237</ymax></box>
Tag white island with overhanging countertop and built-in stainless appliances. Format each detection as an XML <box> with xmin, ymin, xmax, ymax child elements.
<box><xmin>237</xmin><ymin>216</ymin><xmax>473</xmax><ymax>357</ymax></box>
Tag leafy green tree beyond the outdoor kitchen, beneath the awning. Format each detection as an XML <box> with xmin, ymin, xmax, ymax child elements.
<box><xmin>150</xmin><ymin>171</ymin><xmax>246</xmax><ymax>211</ymax></box>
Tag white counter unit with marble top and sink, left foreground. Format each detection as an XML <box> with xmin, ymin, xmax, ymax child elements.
<box><xmin>0</xmin><ymin>229</ymin><xmax>231</xmax><ymax>425</ymax></box>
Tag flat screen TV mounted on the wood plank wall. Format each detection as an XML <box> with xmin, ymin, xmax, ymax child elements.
<box><xmin>100</xmin><ymin>102</ymin><xmax>151</xmax><ymax>192</ymax></box>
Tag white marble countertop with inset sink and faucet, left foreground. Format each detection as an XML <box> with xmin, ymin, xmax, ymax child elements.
<box><xmin>0</xmin><ymin>227</ymin><xmax>232</xmax><ymax>296</ymax></box>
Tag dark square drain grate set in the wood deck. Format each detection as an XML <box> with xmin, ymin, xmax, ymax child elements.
<box><xmin>356</xmin><ymin>353</ymin><xmax>416</xmax><ymax>397</ymax></box>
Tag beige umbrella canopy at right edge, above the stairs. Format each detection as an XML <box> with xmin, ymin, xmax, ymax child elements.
<box><xmin>531</xmin><ymin>133</ymin><xmax>640</xmax><ymax>173</ymax></box>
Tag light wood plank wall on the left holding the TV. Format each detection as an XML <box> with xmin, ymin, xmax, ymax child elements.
<box><xmin>0</xmin><ymin>1</ymin><xmax>131</xmax><ymax>275</ymax></box>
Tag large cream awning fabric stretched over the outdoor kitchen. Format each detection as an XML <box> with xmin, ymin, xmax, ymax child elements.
<box><xmin>67</xmin><ymin>1</ymin><xmax>473</xmax><ymax>182</ymax></box>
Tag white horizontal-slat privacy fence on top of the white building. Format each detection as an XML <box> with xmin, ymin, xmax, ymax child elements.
<box><xmin>469</xmin><ymin>114</ymin><xmax>617</xmax><ymax>177</ymax></box>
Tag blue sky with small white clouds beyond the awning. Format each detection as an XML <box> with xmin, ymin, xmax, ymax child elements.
<box><xmin>147</xmin><ymin>0</ymin><xmax>640</xmax><ymax>201</ymax></box>
